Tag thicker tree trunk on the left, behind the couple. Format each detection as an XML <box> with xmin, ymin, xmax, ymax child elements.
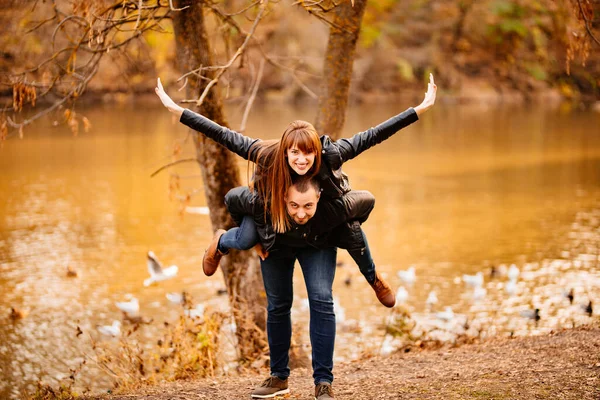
<box><xmin>173</xmin><ymin>0</ymin><xmax>267</xmax><ymax>361</ymax></box>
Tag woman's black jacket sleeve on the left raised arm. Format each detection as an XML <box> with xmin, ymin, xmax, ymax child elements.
<box><xmin>179</xmin><ymin>109</ymin><xmax>260</xmax><ymax>161</ymax></box>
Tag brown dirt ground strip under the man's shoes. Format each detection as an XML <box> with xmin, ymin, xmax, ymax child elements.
<box><xmin>96</xmin><ymin>324</ymin><xmax>600</xmax><ymax>400</ymax></box>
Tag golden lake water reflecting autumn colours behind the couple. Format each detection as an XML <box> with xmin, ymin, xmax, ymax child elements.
<box><xmin>0</xmin><ymin>105</ymin><xmax>600</xmax><ymax>398</ymax></box>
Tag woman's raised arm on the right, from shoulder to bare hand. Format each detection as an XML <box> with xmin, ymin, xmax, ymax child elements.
<box><xmin>335</xmin><ymin>74</ymin><xmax>437</xmax><ymax>162</ymax></box>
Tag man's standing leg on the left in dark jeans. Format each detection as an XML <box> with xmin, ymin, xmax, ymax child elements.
<box><xmin>260</xmin><ymin>250</ymin><xmax>296</xmax><ymax>379</ymax></box>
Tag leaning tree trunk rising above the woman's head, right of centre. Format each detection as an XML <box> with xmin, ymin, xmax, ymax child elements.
<box><xmin>315</xmin><ymin>0</ymin><xmax>367</xmax><ymax>138</ymax></box>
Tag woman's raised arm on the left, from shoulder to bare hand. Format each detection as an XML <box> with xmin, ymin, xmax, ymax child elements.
<box><xmin>154</xmin><ymin>78</ymin><xmax>259</xmax><ymax>161</ymax></box>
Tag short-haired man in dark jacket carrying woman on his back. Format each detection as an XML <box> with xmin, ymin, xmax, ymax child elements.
<box><xmin>225</xmin><ymin>178</ymin><xmax>386</xmax><ymax>400</ymax></box>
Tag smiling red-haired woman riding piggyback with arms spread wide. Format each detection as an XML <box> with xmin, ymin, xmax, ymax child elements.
<box><xmin>155</xmin><ymin>74</ymin><xmax>437</xmax><ymax>307</ymax></box>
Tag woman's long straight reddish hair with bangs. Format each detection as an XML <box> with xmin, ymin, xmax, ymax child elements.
<box><xmin>250</xmin><ymin>121</ymin><xmax>321</xmax><ymax>233</ymax></box>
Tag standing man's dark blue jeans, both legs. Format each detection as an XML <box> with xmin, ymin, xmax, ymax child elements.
<box><xmin>260</xmin><ymin>247</ymin><xmax>337</xmax><ymax>385</ymax></box>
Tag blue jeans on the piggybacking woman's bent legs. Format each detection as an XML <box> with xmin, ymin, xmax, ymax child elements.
<box><xmin>218</xmin><ymin>215</ymin><xmax>375</xmax><ymax>283</ymax></box>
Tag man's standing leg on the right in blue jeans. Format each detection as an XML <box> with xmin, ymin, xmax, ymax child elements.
<box><xmin>298</xmin><ymin>247</ymin><xmax>337</xmax><ymax>385</ymax></box>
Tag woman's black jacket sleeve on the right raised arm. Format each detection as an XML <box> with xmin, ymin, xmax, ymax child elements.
<box><xmin>335</xmin><ymin>107</ymin><xmax>419</xmax><ymax>162</ymax></box>
